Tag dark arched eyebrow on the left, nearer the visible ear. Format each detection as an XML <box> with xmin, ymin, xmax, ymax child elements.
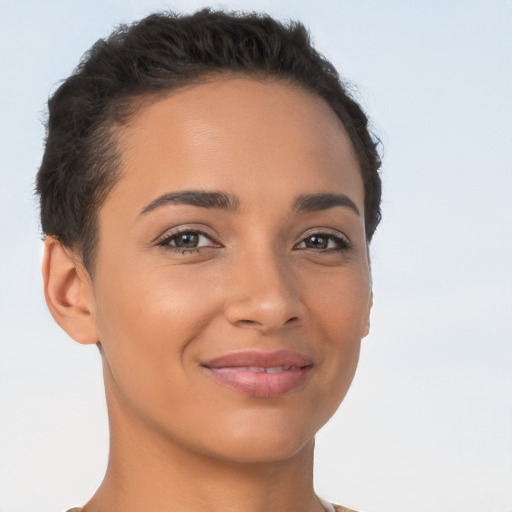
<box><xmin>139</xmin><ymin>190</ymin><xmax>240</xmax><ymax>217</ymax></box>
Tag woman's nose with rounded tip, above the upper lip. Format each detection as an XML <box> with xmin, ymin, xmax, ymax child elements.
<box><xmin>224</xmin><ymin>250</ymin><xmax>306</xmax><ymax>333</ymax></box>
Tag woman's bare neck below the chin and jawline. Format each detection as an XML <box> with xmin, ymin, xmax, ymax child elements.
<box><xmin>84</xmin><ymin>368</ymin><xmax>324</xmax><ymax>512</ymax></box>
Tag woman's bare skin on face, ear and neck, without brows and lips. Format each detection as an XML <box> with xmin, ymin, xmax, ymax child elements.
<box><xmin>43</xmin><ymin>78</ymin><xmax>371</xmax><ymax>512</ymax></box>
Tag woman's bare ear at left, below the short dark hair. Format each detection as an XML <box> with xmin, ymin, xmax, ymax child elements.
<box><xmin>43</xmin><ymin>236</ymin><xmax>99</xmax><ymax>344</ymax></box>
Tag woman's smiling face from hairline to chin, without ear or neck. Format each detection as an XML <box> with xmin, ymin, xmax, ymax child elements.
<box><xmin>89</xmin><ymin>78</ymin><xmax>371</xmax><ymax>461</ymax></box>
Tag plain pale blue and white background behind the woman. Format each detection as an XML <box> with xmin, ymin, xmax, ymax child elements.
<box><xmin>0</xmin><ymin>0</ymin><xmax>512</xmax><ymax>512</ymax></box>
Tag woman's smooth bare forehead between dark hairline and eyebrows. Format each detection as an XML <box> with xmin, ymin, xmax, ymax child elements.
<box><xmin>107</xmin><ymin>78</ymin><xmax>363</xmax><ymax>216</ymax></box>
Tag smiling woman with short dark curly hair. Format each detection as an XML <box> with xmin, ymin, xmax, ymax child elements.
<box><xmin>37</xmin><ymin>10</ymin><xmax>380</xmax><ymax>512</ymax></box>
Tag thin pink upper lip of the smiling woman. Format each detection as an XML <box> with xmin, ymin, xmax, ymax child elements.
<box><xmin>202</xmin><ymin>350</ymin><xmax>313</xmax><ymax>368</ymax></box>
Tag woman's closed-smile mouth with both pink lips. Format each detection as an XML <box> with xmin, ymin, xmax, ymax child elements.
<box><xmin>201</xmin><ymin>350</ymin><xmax>313</xmax><ymax>398</ymax></box>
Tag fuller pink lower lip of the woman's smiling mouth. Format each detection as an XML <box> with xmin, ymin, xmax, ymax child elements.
<box><xmin>205</xmin><ymin>366</ymin><xmax>312</xmax><ymax>398</ymax></box>
